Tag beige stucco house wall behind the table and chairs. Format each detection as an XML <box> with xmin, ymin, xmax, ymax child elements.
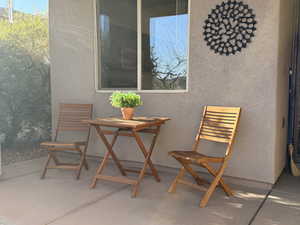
<box><xmin>50</xmin><ymin>0</ymin><xmax>287</xmax><ymax>183</ymax></box>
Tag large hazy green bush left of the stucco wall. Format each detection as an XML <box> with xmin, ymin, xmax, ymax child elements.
<box><xmin>0</xmin><ymin>12</ymin><xmax>51</xmax><ymax>148</ymax></box>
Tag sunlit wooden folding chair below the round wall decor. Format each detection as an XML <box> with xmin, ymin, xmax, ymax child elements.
<box><xmin>169</xmin><ymin>106</ymin><xmax>241</xmax><ymax>207</ymax></box>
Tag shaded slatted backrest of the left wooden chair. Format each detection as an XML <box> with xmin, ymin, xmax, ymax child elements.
<box><xmin>57</xmin><ymin>104</ymin><xmax>93</xmax><ymax>131</ymax></box>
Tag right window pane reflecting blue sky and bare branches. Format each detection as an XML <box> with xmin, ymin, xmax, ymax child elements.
<box><xmin>142</xmin><ymin>0</ymin><xmax>188</xmax><ymax>90</ymax></box>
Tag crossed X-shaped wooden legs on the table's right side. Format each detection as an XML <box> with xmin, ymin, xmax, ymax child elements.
<box><xmin>132</xmin><ymin>126</ymin><xmax>160</xmax><ymax>197</ymax></box>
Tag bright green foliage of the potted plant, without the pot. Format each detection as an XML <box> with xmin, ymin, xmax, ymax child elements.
<box><xmin>110</xmin><ymin>91</ymin><xmax>143</xmax><ymax>108</ymax></box>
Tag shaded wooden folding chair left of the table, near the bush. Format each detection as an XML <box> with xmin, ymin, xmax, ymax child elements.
<box><xmin>40</xmin><ymin>104</ymin><xmax>93</xmax><ymax>179</ymax></box>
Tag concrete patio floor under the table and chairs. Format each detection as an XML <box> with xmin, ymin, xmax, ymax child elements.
<box><xmin>0</xmin><ymin>156</ymin><xmax>300</xmax><ymax>225</ymax></box>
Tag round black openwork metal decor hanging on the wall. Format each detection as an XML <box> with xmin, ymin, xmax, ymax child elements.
<box><xmin>203</xmin><ymin>0</ymin><xmax>257</xmax><ymax>56</ymax></box>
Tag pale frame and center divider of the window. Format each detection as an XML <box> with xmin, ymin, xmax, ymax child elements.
<box><xmin>93</xmin><ymin>0</ymin><xmax>191</xmax><ymax>94</ymax></box>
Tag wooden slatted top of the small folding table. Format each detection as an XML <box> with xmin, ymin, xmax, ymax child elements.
<box><xmin>83</xmin><ymin>117</ymin><xmax>170</xmax><ymax>129</ymax></box>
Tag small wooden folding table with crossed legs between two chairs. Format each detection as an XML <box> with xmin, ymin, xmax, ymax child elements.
<box><xmin>84</xmin><ymin>117</ymin><xmax>169</xmax><ymax>197</ymax></box>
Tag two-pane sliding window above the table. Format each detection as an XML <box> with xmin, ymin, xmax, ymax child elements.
<box><xmin>96</xmin><ymin>0</ymin><xmax>188</xmax><ymax>91</ymax></box>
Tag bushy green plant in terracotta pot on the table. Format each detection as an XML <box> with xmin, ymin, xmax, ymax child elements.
<box><xmin>110</xmin><ymin>92</ymin><xmax>143</xmax><ymax>120</ymax></box>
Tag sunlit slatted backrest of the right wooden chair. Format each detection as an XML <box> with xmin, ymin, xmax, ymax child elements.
<box><xmin>199</xmin><ymin>106</ymin><xmax>241</xmax><ymax>143</ymax></box>
